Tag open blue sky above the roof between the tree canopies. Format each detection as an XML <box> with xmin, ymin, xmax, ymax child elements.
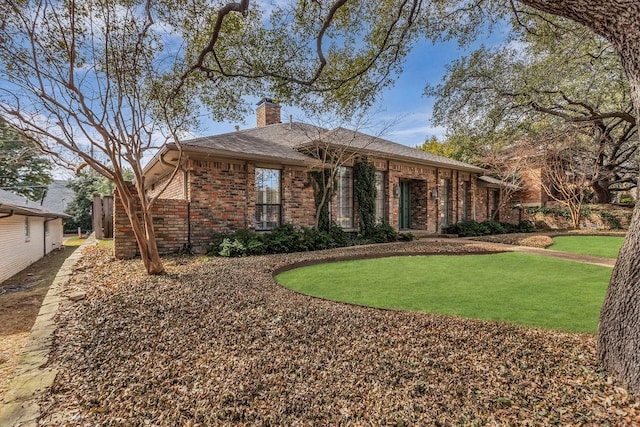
<box><xmin>195</xmin><ymin>34</ymin><xmax>502</xmax><ymax>146</ymax></box>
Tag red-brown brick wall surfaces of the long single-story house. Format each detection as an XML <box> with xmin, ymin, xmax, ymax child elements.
<box><xmin>114</xmin><ymin>152</ymin><xmax>511</xmax><ymax>258</ymax></box>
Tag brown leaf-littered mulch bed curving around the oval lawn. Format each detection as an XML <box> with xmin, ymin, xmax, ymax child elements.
<box><xmin>41</xmin><ymin>241</ymin><xmax>640</xmax><ymax>426</ymax></box>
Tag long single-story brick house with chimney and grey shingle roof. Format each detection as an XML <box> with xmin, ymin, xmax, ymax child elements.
<box><xmin>114</xmin><ymin>99</ymin><xmax>516</xmax><ymax>258</ymax></box>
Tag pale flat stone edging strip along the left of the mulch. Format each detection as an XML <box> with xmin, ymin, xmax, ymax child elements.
<box><xmin>0</xmin><ymin>235</ymin><xmax>95</xmax><ymax>427</ymax></box>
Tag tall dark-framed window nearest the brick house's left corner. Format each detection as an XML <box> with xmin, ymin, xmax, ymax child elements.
<box><xmin>256</xmin><ymin>168</ymin><xmax>282</xmax><ymax>230</ymax></box>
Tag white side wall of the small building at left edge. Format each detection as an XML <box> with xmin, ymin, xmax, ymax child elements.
<box><xmin>0</xmin><ymin>215</ymin><xmax>47</xmax><ymax>282</ymax></box>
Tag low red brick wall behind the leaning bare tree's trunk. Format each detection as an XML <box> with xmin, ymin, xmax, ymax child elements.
<box><xmin>113</xmin><ymin>187</ymin><xmax>188</xmax><ymax>259</ymax></box>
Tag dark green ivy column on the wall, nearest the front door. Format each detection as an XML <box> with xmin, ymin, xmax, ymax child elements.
<box><xmin>353</xmin><ymin>157</ymin><xmax>376</xmax><ymax>236</ymax></box>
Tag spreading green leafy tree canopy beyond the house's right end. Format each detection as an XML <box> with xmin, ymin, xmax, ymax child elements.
<box><xmin>427</xmin><ymin>8</ymin><xmax>638</xmax><ymax>202</ymax></box>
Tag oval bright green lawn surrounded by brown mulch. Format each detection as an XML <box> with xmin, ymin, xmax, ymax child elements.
<box><xmin>276</xmin><ymin>253</ymin><xmax>611</xmax><ymax>333</ymax></box>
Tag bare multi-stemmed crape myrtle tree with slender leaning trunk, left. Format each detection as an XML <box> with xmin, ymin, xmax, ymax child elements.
<box><xmin>0</xmin><ymin>0</ymin><xmax>198</xmax><ymax>273</ymax></box>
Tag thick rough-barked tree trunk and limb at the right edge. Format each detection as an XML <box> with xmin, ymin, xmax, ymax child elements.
<box><xmin>520</xmin><ymin>0</ymin><xmax>640</xmax><ymax>393</ymax></box>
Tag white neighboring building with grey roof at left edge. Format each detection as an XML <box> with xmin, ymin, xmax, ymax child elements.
<box><xmin>0</xmin><ymin>190</ymin><xmax>68</xmax><ymax>282</ymax></box>
